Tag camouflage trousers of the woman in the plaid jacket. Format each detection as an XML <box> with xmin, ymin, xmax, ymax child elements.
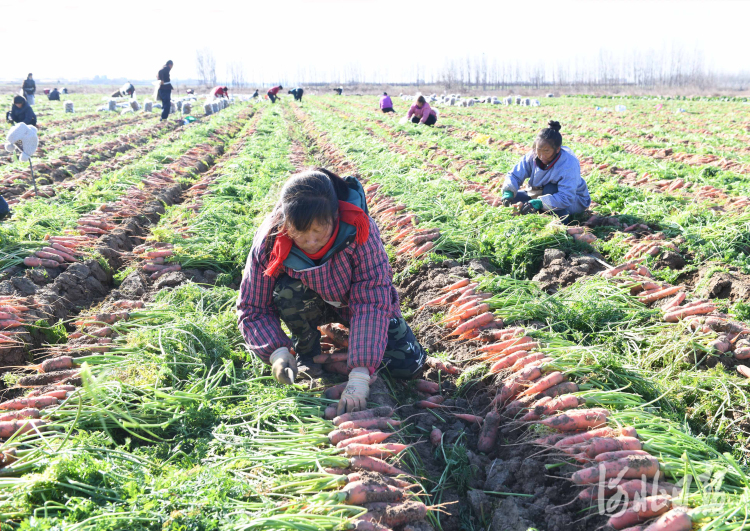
<box><xmin>273</xmin><ymin>274</ymin><xmax>427</xmax><ymax>379</ymax></box>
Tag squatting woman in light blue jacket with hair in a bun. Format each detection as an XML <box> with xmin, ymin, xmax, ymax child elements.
<box><xmin>502</xmin><ymin>121</ymin><xmax>591</xmax><ymax>222</ymax></box>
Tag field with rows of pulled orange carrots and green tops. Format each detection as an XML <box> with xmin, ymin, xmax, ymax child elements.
<box><xmin>0</xmin><ymin>95</ymin><xmax>750</xmax><ymax>531</ymax></box>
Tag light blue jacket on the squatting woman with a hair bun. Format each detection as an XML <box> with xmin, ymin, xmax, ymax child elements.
<box><xmin>502</xmin><ymin>146</ymin><xmax>591</xmax><ymax>214</ymax></box>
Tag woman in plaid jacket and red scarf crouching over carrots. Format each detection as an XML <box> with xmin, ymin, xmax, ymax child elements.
<box><xmin>237</xmin><ymin>168</ymin><xmax>426</xmax><ymax>414</ymax></box>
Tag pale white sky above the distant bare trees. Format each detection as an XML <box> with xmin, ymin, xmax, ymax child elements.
<box><xmin>0</xmin><ymin>0</ymin><xmax>750</xmax><ymax>82</ymax></box>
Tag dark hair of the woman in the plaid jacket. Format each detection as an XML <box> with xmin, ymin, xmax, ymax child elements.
<box><xmin>253</xmin><ymin>168</ymin><xmax>349</xmax><ymax>254</ymax></box>
